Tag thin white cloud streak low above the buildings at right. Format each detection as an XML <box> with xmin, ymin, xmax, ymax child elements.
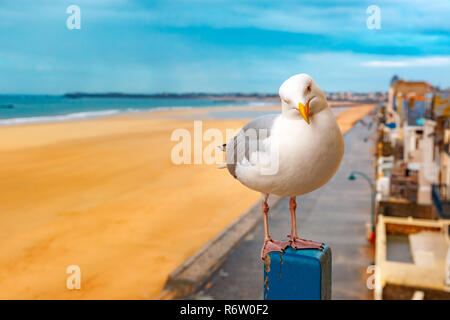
<box><xmin>362</xmin><ymin>56</ymin><xmax>450</xmax><ymax>68</ymax></box>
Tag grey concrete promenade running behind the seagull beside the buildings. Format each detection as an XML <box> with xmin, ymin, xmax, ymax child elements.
<box><xmin>190</xmin><ymin>116</ymin><xmax>374</xmax><ymax>299</ymax></box>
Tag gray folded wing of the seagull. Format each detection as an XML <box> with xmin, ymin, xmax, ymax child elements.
<box><xmin>226</xmin><ymin>114</ymin><xmax>280</xmax><ymax>178</ymax></box>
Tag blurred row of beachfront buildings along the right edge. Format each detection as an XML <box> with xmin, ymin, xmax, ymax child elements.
<box><xmin>375</xmin><ymin>77</ymin><xmax>450</xmax><ymax>299</ymax></box>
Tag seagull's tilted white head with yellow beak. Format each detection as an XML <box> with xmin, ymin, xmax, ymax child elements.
<box><xmin>279</xmin><ymin>73</ymin><xmax>328</xmax><ymax>124</ymax></box>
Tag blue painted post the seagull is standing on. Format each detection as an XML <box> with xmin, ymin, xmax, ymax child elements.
<box><xmin>264</xmin><ymin>245</ymin><xmax>331</xmax><ymax>300</ymax></box>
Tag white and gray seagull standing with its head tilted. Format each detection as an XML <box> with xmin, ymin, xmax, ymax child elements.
<box><xmin>222</xmin><ymin>73</ymin><xmax>344</xmax><ymax>260</ymax></box>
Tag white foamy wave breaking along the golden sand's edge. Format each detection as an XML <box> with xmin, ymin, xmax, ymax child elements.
<box><xmin>0</xmin><ymin>109</ymin><xmax>123</xmax><ymax>126</ymax></box>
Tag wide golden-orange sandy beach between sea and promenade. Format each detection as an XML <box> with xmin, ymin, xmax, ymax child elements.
<box><xmin>0</xmin><ymin>105</ymin><xmax>374</xmax><ymax>299</ymax></box>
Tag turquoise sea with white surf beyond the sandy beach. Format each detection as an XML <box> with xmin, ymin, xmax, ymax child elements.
<box><xmin>0</xmin><ymin>95</ymin><xmax>273</xmax><ymax>126</ymax></box>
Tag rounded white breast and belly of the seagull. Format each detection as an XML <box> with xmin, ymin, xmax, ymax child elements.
<box><xmin>236</xmin><ymin>108</ymin><xmax>344</xmax><ymax>197</ymax></box>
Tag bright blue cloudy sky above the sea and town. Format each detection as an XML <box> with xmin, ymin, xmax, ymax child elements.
<box><xmin>0</xmin><ymin>0</ymin><xmax>450</xmax><ymax>94</ymax></box>
